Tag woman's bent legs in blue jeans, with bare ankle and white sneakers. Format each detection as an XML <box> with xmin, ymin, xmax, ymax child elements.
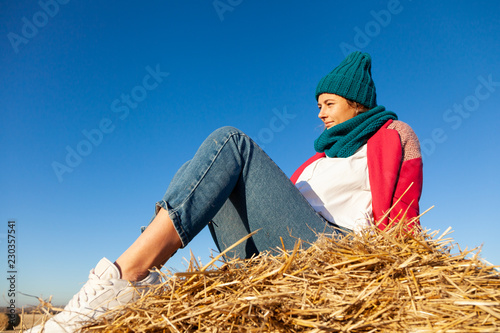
<box><xmin>26</xmin><ymin>127</ymin><xmax>336</xmax><ymax>333</ymax></box>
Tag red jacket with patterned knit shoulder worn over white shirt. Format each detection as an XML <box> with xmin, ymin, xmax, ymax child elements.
<box><xmin>291</xmin><ymin>120</ymin><xmax>423</xmax><ymax>230</ymax></box>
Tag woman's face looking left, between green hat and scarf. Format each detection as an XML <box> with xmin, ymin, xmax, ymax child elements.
<box><xmin>318</xmin><ymin>93</ymin><xmax>358</xmax><ymax>129</ymax></box>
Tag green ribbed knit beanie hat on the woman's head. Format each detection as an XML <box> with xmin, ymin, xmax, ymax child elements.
<box><xmin>316</xmin><ymin>51</ymin><xmax>377</xmax><ymax>109</ymax></box>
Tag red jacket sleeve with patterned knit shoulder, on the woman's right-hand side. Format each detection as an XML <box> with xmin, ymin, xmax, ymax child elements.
<box><xmin>387</xmin><ymin>120</ymin><xmax>423</xmax><ymax>230</ymax></box>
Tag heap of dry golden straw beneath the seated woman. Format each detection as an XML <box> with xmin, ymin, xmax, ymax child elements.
<box><xmin>28</xmin><ymin>218</ymin><xmax>500</xmax><ymax>332</ymax></box>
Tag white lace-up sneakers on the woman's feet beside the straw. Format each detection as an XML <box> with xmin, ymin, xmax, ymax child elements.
<box><xmin>26</xmin><ymin>258</ymin><xmax>161</xmax><ymax>333</ymax></box>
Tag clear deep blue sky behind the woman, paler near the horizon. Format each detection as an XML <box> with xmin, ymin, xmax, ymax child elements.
<box><xmin>0</xmin><ymin>0</ymin><xmax>500</xmax><ymax>306</ymax></box>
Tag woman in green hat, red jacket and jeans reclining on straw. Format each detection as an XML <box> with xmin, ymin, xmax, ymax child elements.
<box><xmin>31</xmin><ymin>52</ymin><xmax>422</xmax><ymax>332</ymax></box>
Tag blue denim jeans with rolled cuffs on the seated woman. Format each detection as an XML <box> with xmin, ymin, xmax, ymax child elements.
<box><xmin>157</xmin><ymin>127</ymin><xmax>346</xmax><ymax>258</ymax></box>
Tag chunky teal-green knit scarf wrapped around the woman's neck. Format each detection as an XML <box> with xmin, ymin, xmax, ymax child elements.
<box><xmin>314</xmin><ymin>105</ymin><xmax>398</xmax><ymax>157</ymax></box>
